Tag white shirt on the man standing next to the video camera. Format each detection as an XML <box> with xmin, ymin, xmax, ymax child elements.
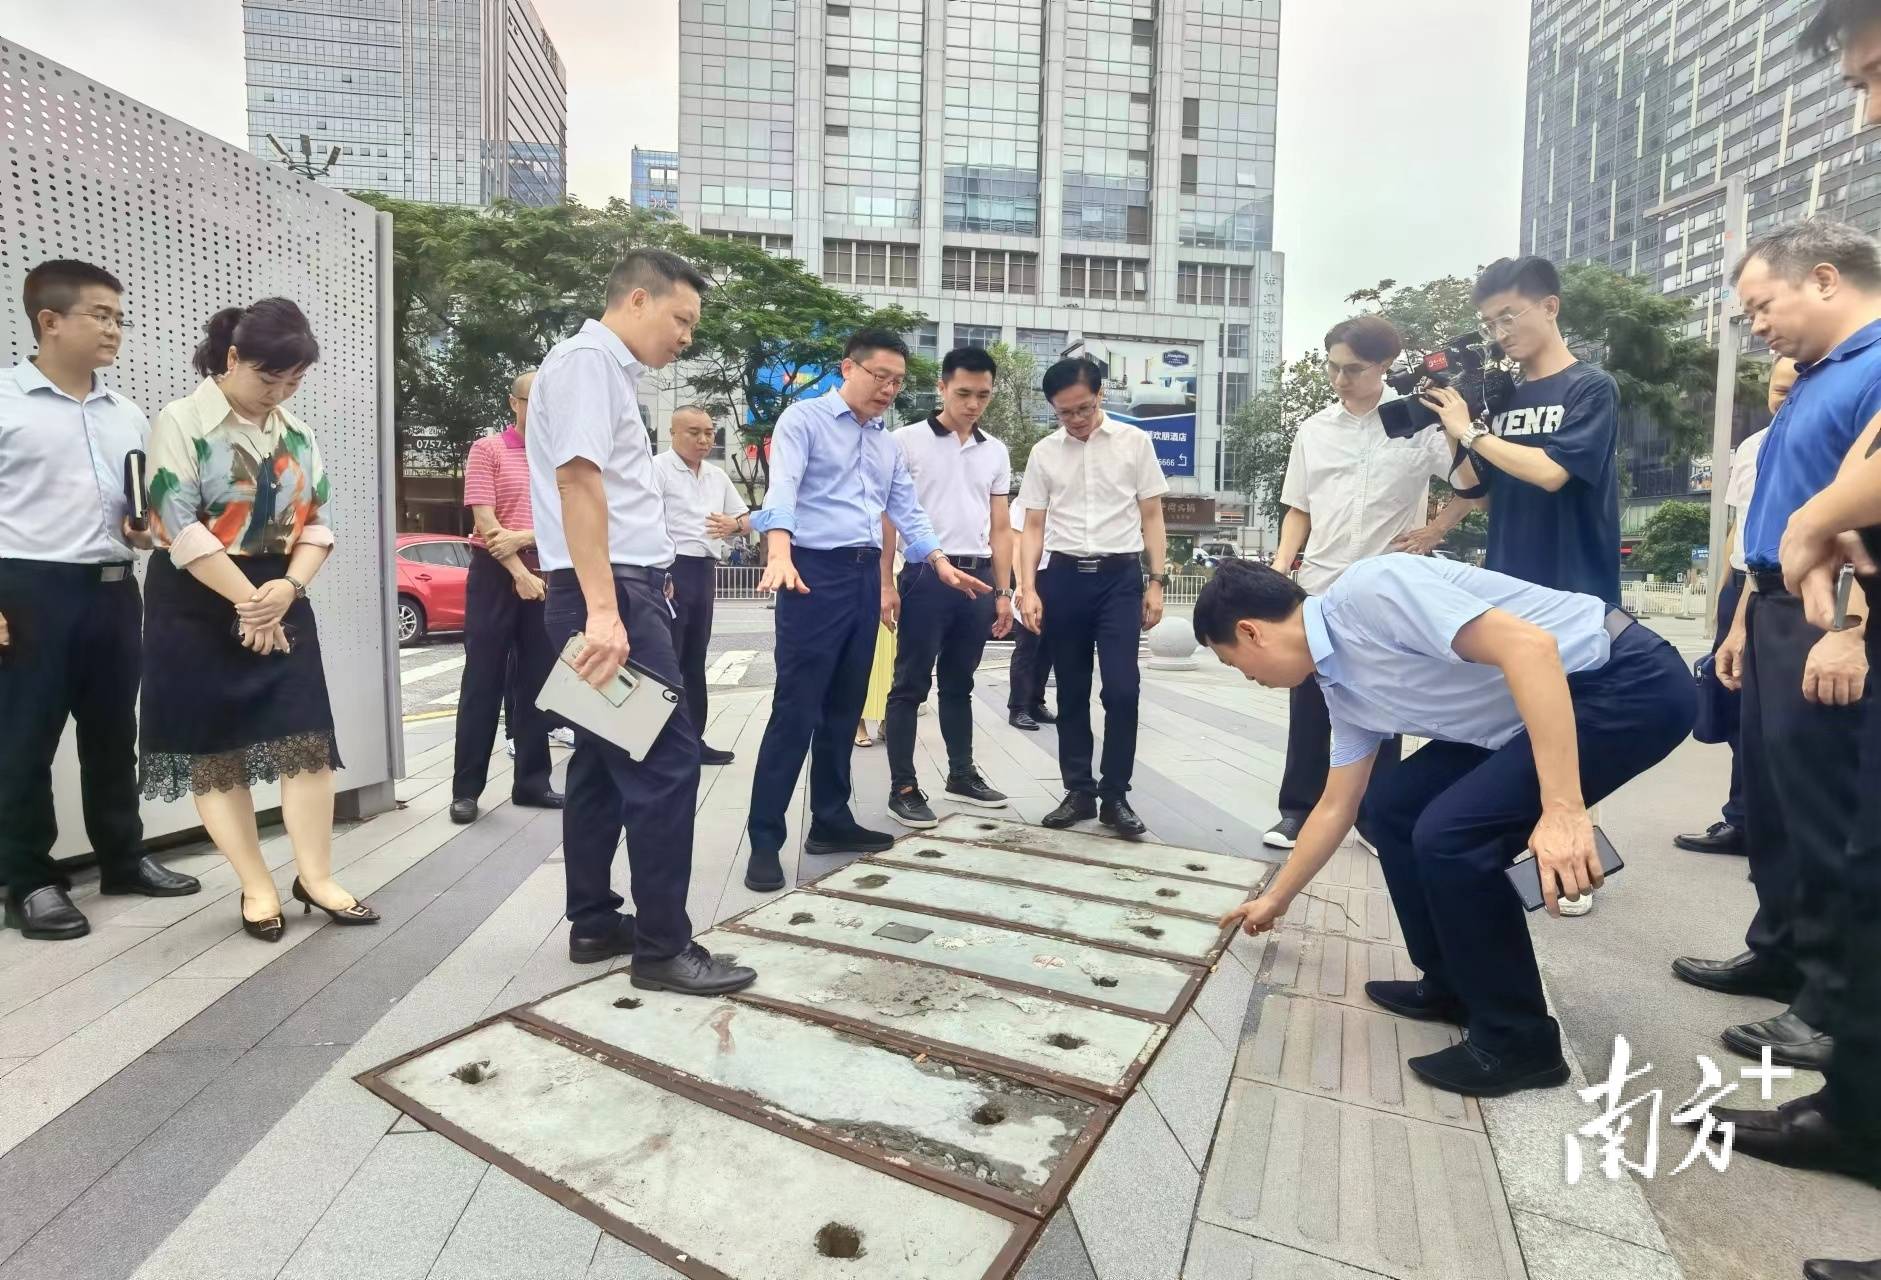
<box><xmin>1281</xmin><ymin>401</ymin><xmax>1454</xmax><ymax>595</ymax></box>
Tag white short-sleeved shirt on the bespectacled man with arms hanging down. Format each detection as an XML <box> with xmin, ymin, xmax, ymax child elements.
<box><xmin>1020</xmin><ymin>416</ymin><xmax>1170</xmax><ymax>557</ymax></box>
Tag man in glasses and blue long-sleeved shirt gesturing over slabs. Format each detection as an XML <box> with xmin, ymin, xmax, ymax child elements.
<box><xmin>745</xmin><ymin>329</ymin><xmax>993</xmax><ymax>892</ymax></box>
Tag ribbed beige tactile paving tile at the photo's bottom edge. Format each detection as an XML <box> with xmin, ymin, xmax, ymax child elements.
<box><xmin>1202</xmin><ymin>1080</ymin><xmax>1524</xmax><ymax>1280</ymax></box>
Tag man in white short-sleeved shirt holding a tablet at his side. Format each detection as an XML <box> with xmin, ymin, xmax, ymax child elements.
<box><xmin>527</xmin><ymin>248</ymin><xmax>756</xmax><ymax>996</ymax></box>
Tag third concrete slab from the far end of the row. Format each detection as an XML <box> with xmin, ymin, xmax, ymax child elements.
<box><xmin>814</xmin><ymin>862</ymin><xmax>1223</xmax><ymax>964</ymax></box>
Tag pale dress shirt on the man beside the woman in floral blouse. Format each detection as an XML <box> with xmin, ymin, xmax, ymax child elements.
<box><xmin>0</xmin><ymin>361</ymin><xmax>150</xmax><ymax>565</ymax></box>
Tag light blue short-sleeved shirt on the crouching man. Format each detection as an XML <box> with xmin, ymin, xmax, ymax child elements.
<box><xmin>1302</xmin><ymin>553</ymin><xmax>1612</xmax><ymax>768</ymax></box>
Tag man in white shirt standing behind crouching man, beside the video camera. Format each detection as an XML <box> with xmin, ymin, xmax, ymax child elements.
<box><xmin>1262</xmin><ymin>316</ymin><xmax>1478</xmax><ymax>849</ymax></box>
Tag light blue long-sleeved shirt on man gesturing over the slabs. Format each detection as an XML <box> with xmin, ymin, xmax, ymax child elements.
<box><xmin>751</xmin><ymin>392</ymin><xmax>941</xmax><ymax>561</ymax></box>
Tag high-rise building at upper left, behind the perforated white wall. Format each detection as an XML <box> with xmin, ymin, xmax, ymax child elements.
<box><xmin>243</xmin><ymin>0</ymin><xmax>568</xmax><ymax>205</ymax></box>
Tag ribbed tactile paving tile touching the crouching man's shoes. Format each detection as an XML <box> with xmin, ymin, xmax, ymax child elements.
<box><xmin>1234</xmin><ymin>992</ymin><xmax>1482</xmax><ymax>1129</ymax></box>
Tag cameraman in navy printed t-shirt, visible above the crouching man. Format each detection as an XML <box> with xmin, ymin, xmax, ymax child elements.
<box><xmin>1424</xmin><ymin>256</ymin><xmax>1620</xmax><ymax>606</ymax></box>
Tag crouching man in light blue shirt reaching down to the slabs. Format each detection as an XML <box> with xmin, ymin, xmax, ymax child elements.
<box><xmin>1194</xmin><ymin>555</ymin><xmax>1695</xmax><ymax>1096</ymax></box>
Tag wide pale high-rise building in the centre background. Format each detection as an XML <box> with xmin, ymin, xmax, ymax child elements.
<box><xmin>679</xmin><ymin>0</ymin><xmax>1281</xmax><ymax>493</ymax></box>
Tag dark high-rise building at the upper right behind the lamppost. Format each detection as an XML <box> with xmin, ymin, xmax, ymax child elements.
<box><xmin>1522</xmin><ymin>0</ymin><xmax>1881</xmax><ymax>538</ymax></box>
